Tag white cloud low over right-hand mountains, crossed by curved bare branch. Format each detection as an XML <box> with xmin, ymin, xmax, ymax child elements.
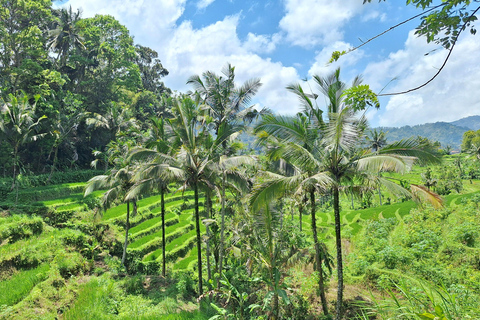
<box><xmin>365</xmin><ymin>31</ymin><xmax>480</xmax><ymax>126</ymax></box>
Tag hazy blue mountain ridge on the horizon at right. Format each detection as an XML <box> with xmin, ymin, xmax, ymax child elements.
<box><xmin>378</xmin><ymin>116</ymin><xmax>480</xmax><ymax>151</ymax></box>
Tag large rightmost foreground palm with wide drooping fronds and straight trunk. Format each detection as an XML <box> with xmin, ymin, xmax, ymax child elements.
<box><xmin>257</xmin><ymin>70</ymin><xmax>440</xmax><ymax>319</ymax></box>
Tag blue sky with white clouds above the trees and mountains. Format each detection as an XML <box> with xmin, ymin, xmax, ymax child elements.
<box><xmin>56</xmin><ymin>0</ymin><xmax>480</xmax><ymax>127</ymax></box>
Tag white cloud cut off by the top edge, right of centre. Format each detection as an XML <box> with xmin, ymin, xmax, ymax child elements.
<box><xmin>280</xmin><ymin>0</ymin><xmax>363</xmax><ymax>48</ymax></box>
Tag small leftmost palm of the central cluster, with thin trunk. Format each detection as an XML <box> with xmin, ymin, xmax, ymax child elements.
<box><xmin>84</xmin><ymin>142</ymin><xmax>137</xmax><ymax>267</ymax></box>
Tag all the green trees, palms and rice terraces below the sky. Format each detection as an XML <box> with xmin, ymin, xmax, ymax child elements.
<box><xmin>0</xmin><ymin>0</ymin><xmax>480</xmax><ymax>320</ymax></box>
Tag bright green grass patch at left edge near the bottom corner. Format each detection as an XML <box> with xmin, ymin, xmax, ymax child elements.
<box><xmin>0</xmin><ymin>264</ymin><xmax>50</xmax><ymax>306</ymax></box>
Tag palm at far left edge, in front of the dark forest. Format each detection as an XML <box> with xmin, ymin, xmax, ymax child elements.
<box><xmin>0</xmin><ymin>93</ymin><xmax>46</xmax><ymax>190</ymax></box>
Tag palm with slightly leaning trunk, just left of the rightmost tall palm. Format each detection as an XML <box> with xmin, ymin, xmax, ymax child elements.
<box><xmin>250</xmin><ymin>111</ymin><xmax>330</xmax><ymax>315</ymax></box>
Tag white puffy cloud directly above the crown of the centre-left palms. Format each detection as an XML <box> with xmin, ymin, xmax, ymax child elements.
<box><xmin>163</xmin><ymin>16</ymin><xmax>298</xmax><ymax>114</ymax></box>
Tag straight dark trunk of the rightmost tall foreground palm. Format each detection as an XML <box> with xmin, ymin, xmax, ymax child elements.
<box><xmin>333</xmin><ymin>185</ymin><xmax>343</xmax><ymax>320</ymax></box>
